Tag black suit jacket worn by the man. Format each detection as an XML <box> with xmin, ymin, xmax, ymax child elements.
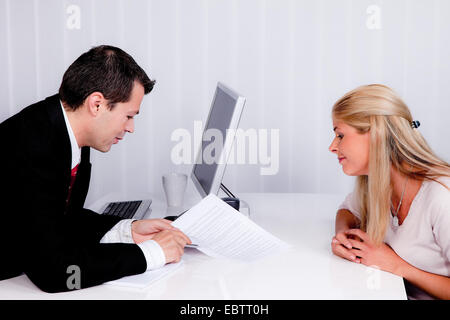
<box><xmin>0</xmin><ymin>95</ymin><xmax>146</xmax><ymax>292</ymax></box>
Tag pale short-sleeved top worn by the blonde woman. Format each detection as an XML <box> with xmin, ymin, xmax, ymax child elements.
<box><xmin>339</xmin><ymin>177</ymin><xmax>450</xmax><ymax>299</ymax></box>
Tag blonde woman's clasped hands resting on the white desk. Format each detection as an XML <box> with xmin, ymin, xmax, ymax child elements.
<box><xmin>344</xmin><ymin>229</ymin><xmax>405</xmax><ymax>276</ymax></box>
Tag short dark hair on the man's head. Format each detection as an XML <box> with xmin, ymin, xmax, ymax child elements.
<box><xmin>59</xmin><ymin>45</ymin><xmax>155</xmax><ymax>110</ymax></box>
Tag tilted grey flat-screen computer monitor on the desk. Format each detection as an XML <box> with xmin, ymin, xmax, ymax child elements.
<box><xmin>191</xmin><ymin>82</ymin><xmax>245</xmax><ymax>197</ymax></box>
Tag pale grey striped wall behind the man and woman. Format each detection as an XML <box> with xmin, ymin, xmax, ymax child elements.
<box><xmin>0</xmin><ymin>0</ymin><xmax>450</xmax><ymax>206</ymax></box>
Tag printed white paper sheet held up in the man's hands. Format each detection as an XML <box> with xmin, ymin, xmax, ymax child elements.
<box><xmin>172</xmin><ymin>194</ymin><xmax>289</xmax><ymax>261</ymax></box>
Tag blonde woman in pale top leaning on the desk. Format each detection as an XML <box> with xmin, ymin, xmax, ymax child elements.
<box><xmin>329</xmin><ymin>84</ymin><xmax>450</xmax><ymax>299</ymax></box>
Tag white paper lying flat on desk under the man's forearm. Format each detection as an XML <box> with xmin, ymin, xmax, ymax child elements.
<box><xmin>105</xmin><ymin>260</ymin><xmax>183</xmax><ymax>288</ymax></box>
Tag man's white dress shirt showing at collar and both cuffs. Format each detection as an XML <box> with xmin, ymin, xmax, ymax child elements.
<box><xmin>60</xmin><ymin>101</ymin><xmax>166</xmax><ymax>270</ymax></box>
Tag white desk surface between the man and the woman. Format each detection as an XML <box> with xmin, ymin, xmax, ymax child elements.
<box><xmin>0</xmin><ymin>193</ymin><xmax>406</xmax><ymax>300</ymax></box>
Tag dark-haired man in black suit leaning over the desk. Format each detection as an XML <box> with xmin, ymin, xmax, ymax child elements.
<box><xmin>0</xmin><ymin>46</ymin><xmax>190</xmax><ymax>292</ymax></box>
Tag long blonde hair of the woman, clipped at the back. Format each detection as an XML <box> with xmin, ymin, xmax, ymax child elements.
<box><xmin>332</xmin><ymin>84</ymin><xmax>450</xmax><ymax>244</ymax></box>
